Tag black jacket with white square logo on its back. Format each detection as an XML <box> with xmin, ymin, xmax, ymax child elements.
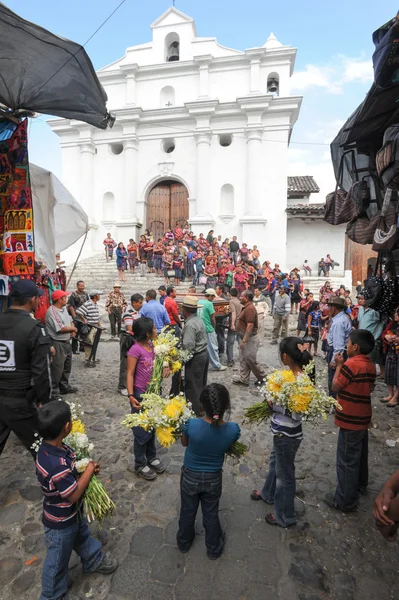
<box><xmin>0</xmin><ymin>308</ymin><xmax>51</xmax><ymax>404</ymax></box>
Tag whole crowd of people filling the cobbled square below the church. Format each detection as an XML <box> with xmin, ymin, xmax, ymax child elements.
<box><xmin>0</xmin><ymin>230</ymin><xmax>399</xmax><ymax>600</ymax></box>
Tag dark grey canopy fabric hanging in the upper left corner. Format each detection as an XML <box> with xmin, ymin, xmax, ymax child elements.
<box><xmin>0</xmin><ymin>3</ymin><xmax>114</xmax><ymax>129</ymax></box>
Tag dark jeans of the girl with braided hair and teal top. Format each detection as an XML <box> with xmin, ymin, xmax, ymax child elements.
<box><xmin>177</xmin><ymin>467</ymin><xmax>224</xmax><ymax>558</ymax></box>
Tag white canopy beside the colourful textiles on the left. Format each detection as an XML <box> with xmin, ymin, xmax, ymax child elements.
<box><xmin>30</xmin><ymin>163</ymin><xmax>89</xmax><ymax>271</ymax></box>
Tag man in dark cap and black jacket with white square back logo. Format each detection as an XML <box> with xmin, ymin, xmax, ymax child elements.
<box><xmin>0</xmin><ymin>280</ymin><xmax>51</xmax><ymax>456</ymax></box>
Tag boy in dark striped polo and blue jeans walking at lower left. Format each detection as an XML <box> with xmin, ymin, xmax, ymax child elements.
<box><xmin>36</xmin><ymin>401</ymin><xmax>118</xmax><ymax>600</ymax></box>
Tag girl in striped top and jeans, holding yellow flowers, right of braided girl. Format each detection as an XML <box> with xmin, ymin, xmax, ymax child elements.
<box><xmin>251</xmin><ymin>337</ymin><xmax>312</xmax><ymax>527</ymax></box>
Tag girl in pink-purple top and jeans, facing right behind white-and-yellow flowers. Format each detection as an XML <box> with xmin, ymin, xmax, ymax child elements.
<box><xmin>126</xmin><ymin>317</ymin><xmax>165</xmax><ymax>481</ymax></box>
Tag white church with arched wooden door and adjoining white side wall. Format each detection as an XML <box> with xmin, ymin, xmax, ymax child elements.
<box><xmin>49</xmin><ymin>7</ymin><xmax>344</xmax><ymax>267</ymax></box>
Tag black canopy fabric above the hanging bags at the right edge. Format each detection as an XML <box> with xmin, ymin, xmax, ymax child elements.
<box><xmin>331</xmin><ymin>85</ymin><xmax>399</xmax><ymax>204</ymax></box>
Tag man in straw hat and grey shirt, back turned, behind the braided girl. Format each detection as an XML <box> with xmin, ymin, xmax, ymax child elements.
<box><xmin>181</xmin><ymin>296</ymin><xmax>209</xmax><ymax>416</ymax></box>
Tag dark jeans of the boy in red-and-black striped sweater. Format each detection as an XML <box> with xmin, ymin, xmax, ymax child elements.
<box><xmin>335</xmin><ymin>428</ymin><xmax>369</xmax><ymax>510</ymax></box>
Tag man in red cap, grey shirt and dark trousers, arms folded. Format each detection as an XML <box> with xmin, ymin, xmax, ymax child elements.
<box><xmin>45</xmin><ymin>290</ymin><xmax>78</xmax><ymax>400</ymax></box>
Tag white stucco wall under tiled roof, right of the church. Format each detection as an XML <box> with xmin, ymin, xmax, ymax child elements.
<box><xmin>287</xmin><ymin>218</ymin><xmax>346</xmax><ymax>274</ymax></box>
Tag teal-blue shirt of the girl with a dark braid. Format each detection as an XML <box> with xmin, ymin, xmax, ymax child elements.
<box><xmin>182</xmin><ymin>419</ymin><xmax>241</xmax><ymax>473</ymax></box>
